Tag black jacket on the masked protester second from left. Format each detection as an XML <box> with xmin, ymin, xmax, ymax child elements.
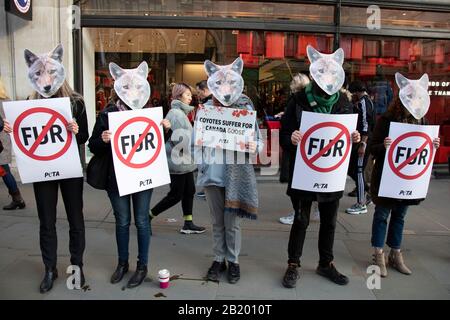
<box><xmin>88</xmin><ymin>105</ymin><xmax>172</xmax><ymax>191</ymax></box>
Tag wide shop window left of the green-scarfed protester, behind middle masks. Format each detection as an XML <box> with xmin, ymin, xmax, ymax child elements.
<box><xmin>83</xmin><ymin>28</ymin><xmax>334</xmax><ymax>117</ymax></box>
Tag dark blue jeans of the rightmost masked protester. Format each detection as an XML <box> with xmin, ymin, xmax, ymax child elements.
<box><xmin>372</xmin><ymin>205</ymin><xmax>408</xmax><ymax>249</ymax></box>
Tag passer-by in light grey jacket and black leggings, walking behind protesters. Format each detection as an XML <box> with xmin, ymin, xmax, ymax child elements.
<box><xmin>150</xmin><ymin>83</ymin><xmax>205</xmax><ymax>234</ymax></box>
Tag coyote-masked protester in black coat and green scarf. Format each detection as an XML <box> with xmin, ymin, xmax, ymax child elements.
<box><xmin>280</xmin><ymin>46</ymin><xmax>360</xmax><ymax>288</ymax></box>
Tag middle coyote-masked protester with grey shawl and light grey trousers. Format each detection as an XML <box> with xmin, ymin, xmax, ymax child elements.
<box><xmin>194</xmin><ymin>58</ymin><xmax>263</xmax><ymax>284</ymax></box>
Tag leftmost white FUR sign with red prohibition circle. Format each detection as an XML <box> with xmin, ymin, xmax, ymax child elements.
<box><xmin>3</xmin><ymin>98</ymin><xmax>83</xmax><ymax>183</ymax></box>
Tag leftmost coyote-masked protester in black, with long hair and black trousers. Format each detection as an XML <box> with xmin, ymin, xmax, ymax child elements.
<box><xmin>11</xmin><ymin>45</ymin><xmax>89</xmax><ymax>293</ymax></box>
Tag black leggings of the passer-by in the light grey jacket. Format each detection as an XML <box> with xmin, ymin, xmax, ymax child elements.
<box><xmin>152</xmin><ymin>172</ymin><xmax>195</xmax><ymax>216</ymax></box>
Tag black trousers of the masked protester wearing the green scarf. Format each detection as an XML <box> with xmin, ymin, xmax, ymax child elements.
<box><xmin>288</xmin><ymin>197</ymin><xmax>339</xmax><ymax>266</ymax></box>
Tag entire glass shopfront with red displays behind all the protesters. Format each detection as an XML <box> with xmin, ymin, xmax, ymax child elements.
<box><xmin>80</xmin><ymin>0</ymin><xmax>450</xmax><ymax>160</ymax></box>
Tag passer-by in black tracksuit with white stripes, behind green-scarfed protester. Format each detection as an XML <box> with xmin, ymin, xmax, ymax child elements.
<box><xmin>345</xmin><ymin>80</ymin><xmax>375</xmax><ymax>214</ymax></box>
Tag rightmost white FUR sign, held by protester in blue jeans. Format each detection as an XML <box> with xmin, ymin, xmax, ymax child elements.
<box><xmin>378</xmin><ymin>122</ymin><xmax>439</xmax><ymax>199</ymax></box>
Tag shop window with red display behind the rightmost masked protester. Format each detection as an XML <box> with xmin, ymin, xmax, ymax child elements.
<box><xmin>341</xmin><ymin>35</ymin><xmax>450</xmax><ymax>125</ymax></box>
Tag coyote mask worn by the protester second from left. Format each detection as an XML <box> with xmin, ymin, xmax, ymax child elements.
<box><xmin>109</xmin><ymin>61</ymin><xmax>150</xmax><ymax>109</ymax></box>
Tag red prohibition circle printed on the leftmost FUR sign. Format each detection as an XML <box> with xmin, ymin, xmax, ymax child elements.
<box><xmin>13</xmin><ymin>107</ymin><xmax>72</xmax><ymax>161</ymax></box>
